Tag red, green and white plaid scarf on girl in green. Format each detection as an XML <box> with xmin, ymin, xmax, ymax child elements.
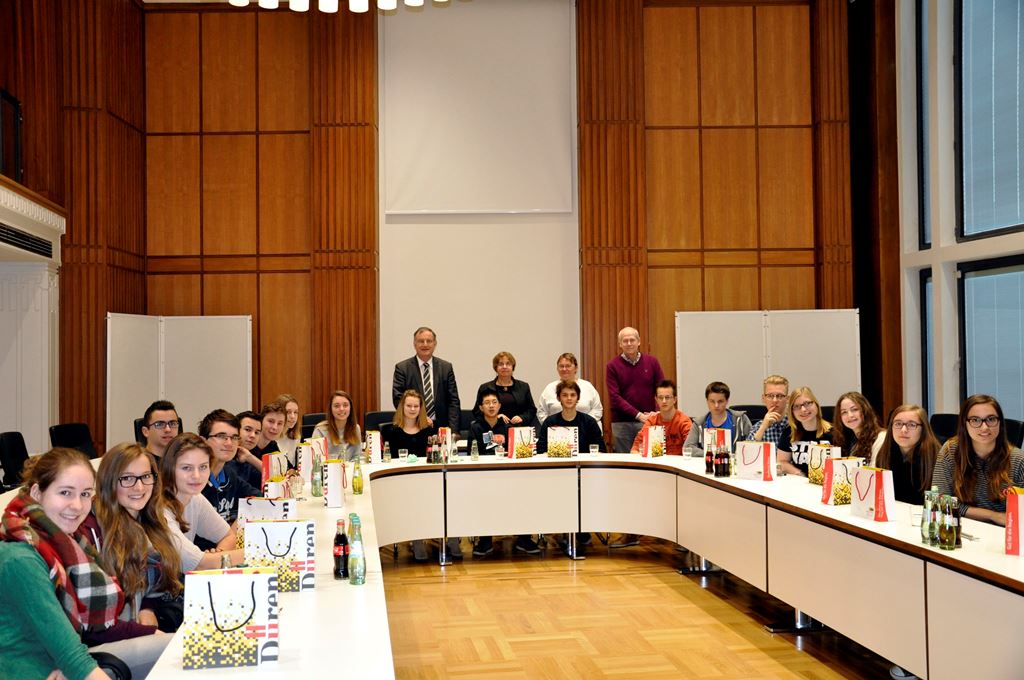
<box><xmin>0</xmin><ymin>491</ymin><xmax>124</xmax><ymax>633</ymax></box>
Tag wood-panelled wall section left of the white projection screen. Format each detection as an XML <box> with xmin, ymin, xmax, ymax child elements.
<box><xmin>145</xmin><ymin>8</ymin><xmax>378</xmax><ymax>421</ymax></box>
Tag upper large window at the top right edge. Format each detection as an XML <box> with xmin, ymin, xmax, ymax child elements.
<box><xmin>954</xmin><ymin>0</ymin><xmax>1024</xmax><ymax>239</ymax></box>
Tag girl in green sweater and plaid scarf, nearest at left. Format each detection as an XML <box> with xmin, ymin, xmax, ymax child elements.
<box><xmin>0</xmin><ymin>449</ymin><xmax>171</xmax><ymax>680</ymax></box>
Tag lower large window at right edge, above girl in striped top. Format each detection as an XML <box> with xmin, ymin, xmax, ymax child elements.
<box><xmin>957</xmin><ymin>255</ymin><xmax>1024</xmax><ymax>420</ymax></box>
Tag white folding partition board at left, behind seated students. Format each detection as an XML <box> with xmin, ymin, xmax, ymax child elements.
<box><xmin>106</xmin><ymin>313</ymin><xmax>252</xmax><ymax>445</ymax></box>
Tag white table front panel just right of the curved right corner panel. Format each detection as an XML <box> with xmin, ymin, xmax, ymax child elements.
<box><xmin>676</xmin><ymin>477</ymin><xmax>768</xmax><ymax>590</ymax></box>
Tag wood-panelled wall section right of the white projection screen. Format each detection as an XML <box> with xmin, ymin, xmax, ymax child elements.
<box><xmin>578</xmin><ymin>0</ymin><xmax>852</xmax><ymax>403</ymax></box>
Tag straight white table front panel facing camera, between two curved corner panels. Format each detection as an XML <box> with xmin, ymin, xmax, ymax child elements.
<box><xmin>446</xmin><ymin>466</ymin><xmax>580</xmax><ymax>536</ymax></box>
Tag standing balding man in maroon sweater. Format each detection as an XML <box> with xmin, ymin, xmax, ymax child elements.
<box><xmin>604</xmin><ymin>327</ymin><xmax>665</xmax><ymax>454</ymax></box>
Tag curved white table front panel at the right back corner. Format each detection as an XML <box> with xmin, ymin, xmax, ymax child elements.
<box><xmin>580</xmin><ymin>459</ymin><xmax>676</xmax><ymax>542</ymax></box>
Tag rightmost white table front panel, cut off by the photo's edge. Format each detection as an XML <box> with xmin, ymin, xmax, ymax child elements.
<box><xmin>928</xmin><ymin>557</ymin><xmax>1024</xmax><ymax>680</ymax></box>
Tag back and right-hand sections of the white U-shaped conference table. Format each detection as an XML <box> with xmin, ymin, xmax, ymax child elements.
<box><xmin>368</xmin><ymin>454</ymin><xmax>1024</xmax><ymax>679</ymax></box>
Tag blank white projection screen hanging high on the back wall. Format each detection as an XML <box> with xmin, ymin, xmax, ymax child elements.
<box><xmin>381</xmin><ymin>0</ymin><xmax>575</xmax><ymax>215</ymax></box>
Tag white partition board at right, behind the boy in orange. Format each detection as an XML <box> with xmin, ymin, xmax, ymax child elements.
<box><xmin>676</xmin><ymin>309</ymin><xmax>860</xmax><ymax>418</ymax></box>
